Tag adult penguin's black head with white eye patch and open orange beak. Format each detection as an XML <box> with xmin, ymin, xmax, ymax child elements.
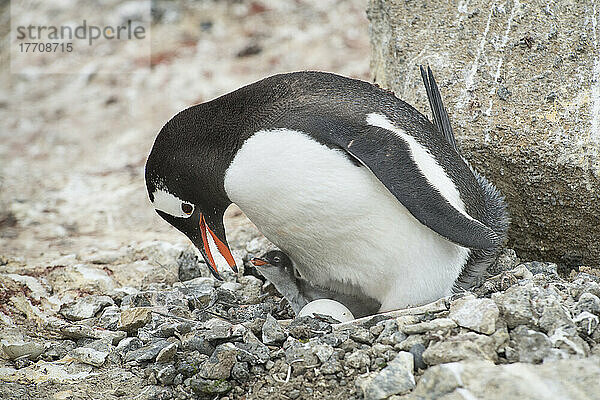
<box><xmin>146</xmin><ymin>104</ymin><xmax>237</xmax><ymax>279</ymax></box>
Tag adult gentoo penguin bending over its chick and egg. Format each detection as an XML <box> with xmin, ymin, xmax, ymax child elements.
<box><xmin>146</xmin><ymin>67</ymin><xmax>508</xmax><ymax>311</ymax></box>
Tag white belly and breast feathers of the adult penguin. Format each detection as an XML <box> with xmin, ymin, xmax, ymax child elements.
<box><xmin>225</xmin><ymin>129</ymin><xmax>469</xmax><ymax>311</ymax></box>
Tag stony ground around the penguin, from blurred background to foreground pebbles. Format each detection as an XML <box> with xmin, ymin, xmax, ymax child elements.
<box><xmin>0</xmin><ymin>0</ymin><xmax>600</xmax><ymax>399</ymax></box>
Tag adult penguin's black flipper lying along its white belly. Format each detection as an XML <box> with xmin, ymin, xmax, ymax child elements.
<box><xmin>295</xmin><ymin>116</ymin><xmax>499</xmax><ymax>249</ymax></box>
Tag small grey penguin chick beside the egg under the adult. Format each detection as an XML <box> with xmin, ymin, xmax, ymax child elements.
<box><xmin>251</xmin><ymin>250</ymin><xmax>381</xmax><ymax>318</ymax></box>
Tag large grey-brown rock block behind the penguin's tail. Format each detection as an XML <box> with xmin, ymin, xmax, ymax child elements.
<box><xmin>367</xmin><ymin>0</ymin><xmax>600</xmax><ymax>265</ymax></box>
